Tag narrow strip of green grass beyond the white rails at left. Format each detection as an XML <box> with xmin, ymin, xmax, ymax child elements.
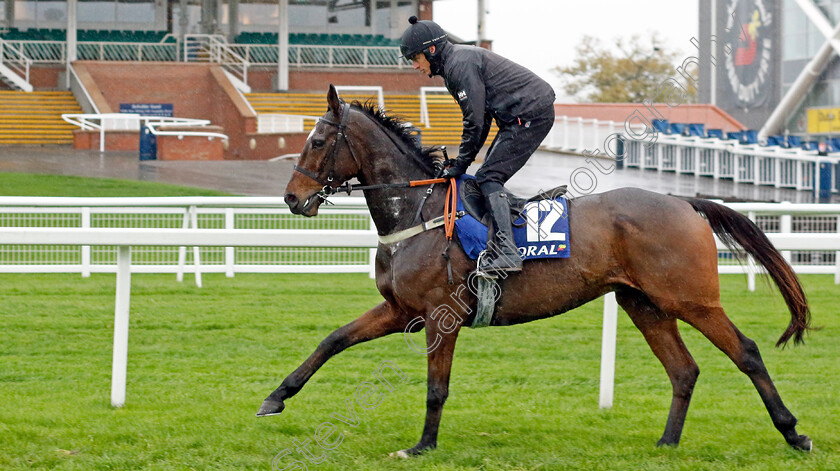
<box><xmin>0</xmin><ymin>172</ymin><xmax>229</xmax><ymax>197</ymax></box>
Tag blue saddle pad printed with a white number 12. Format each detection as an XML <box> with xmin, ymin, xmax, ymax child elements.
<box><xmin>455</xmin><ymin>175</ymin><xmax>570</xmax><ymax>260</ymax></box>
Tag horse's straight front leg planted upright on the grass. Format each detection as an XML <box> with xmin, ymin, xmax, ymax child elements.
<box><xmin>392</xmin><ymin>317</ymin><xmax>460</xmax><ymax>458</ymax></box>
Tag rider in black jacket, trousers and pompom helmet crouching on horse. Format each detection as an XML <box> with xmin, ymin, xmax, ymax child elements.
<box><xmin>400</xmin><ymin>16</ymin><xmax>554</xmax><ymax>272</ymax></box>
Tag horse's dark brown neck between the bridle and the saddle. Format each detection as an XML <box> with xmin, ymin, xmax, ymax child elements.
<box><xmin>360</xmin><ymin>129</ymin><xmax>442</xmax><ymax>235</ymax></box>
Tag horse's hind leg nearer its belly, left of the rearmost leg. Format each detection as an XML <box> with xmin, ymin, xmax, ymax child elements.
<box><xmin>616</xmin><ymin>292</ymin><xmax>700</xmax><ymax>446</ymax></box>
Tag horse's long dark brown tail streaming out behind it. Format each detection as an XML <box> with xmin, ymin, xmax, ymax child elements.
<box><xmin>684</xmin><ymin>198</ymin><xmax>811</xmax><ymax>347</ymax></box>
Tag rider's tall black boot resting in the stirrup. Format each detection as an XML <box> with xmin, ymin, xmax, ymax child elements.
<box><xmin>479</xmin><ymin>190</ymin><xmax>522</xmax><ymax>273</ymax></box>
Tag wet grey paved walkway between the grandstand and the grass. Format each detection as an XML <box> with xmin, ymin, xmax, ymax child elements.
<box><xmin>0</xmin><ymin>147</ymin><xmax>828</xmax><ymax>203</ymax></box>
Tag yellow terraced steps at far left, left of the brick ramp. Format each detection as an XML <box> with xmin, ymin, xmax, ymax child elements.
<box><xmin>0</xmin><ymin>90</ymin><xmax>82</xmax><ymax>145</ymax></box>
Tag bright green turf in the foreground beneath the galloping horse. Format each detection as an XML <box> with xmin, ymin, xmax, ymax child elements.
<box><xmin>0</xmin><ymin>274</ymin><xmax>840</xmax><ymax>471</ymax></box>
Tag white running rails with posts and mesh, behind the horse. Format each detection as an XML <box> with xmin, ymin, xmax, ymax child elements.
<box><xmin>0</xmin><ymin>197</ymin><xmax>840</xmax><ymax>408</ymax></box>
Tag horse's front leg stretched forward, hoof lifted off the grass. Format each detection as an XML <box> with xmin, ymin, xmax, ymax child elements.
<box><xmin>257</xmin><ymin>301</ymin><xmax>409</xmax><ymax>417</ymax></box>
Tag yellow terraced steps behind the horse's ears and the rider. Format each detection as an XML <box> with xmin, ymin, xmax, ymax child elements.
<box><xmin>245</xmin><ymin>93</ymin><xmax>496</xmax><ymax>148</ymax></box>
